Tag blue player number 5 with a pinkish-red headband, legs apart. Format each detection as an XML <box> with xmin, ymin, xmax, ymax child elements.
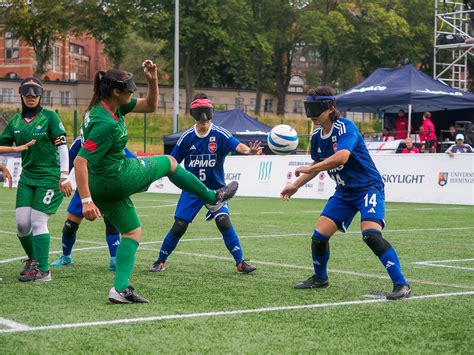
<box><xmin>149</xmin><ymin>93</ymin><xmax>262</xmax><ymax>274</ymax></box>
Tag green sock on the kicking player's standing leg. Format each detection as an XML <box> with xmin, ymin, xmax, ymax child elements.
<box><xmin>114</xmin><ymin>238</ymin><xmax>138</xmax><ymax>291</ymax></box>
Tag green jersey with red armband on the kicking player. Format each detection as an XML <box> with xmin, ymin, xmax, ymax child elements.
<box><xmin>78</xmin><ymin>99</ymin><xmax>137</xmax><ymax>176</ymax></box>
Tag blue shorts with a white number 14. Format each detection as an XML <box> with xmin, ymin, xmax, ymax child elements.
<box><xmin>321</xmin><ymin>187</ymin><xmax>385</xmax><ymax>232</ymax></box>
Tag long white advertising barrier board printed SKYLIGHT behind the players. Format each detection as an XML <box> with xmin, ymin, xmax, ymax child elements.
<box><xmin>4</xmin><ymin>154</ymin><xmax>474</xmax><ymax>205</ymax></box>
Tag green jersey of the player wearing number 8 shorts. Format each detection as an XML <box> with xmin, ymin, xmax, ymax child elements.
<box><xmin>0</xmin><ymin>108</ymin><xmax>66</xmax><ymax>187</ymax></box>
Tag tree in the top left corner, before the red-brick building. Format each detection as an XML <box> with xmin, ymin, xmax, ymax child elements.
<box><xmin>3</xmin><ymin>0</ymin><xmax>75</xmax><ymax>78</ymax></box>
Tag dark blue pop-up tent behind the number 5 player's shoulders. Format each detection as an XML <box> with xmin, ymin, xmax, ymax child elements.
<box><xmin>163</xmin><ymin>109</ymin><xmax>273</xmax><ymax>154</ymax></box>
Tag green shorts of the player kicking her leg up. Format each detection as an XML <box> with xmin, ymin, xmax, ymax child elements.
<box><xmin>89</xmin><ymin>156</ymin><xmax>171</xmax><ymax>234</ymax></box>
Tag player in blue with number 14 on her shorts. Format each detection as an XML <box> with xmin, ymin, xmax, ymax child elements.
<box><xmin>280</xmin><ymin>86</ymin><xmax>411</xmax><ymax>300</ymax></box>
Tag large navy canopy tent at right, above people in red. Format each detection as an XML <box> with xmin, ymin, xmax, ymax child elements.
<box><xmin>336</xmin><ymin>64</ymin><xmax>474</xmax><ymax>132</ymax></box>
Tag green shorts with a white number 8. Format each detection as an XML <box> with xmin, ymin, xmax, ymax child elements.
<box><xmin>16</xmin><ymin>181</ymin><xmax>64</xmax><ymax>214</ymax></box>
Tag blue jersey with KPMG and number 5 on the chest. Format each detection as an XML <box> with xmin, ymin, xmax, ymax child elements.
<box><xmin>171</xmin><ymin>123</ymin><xmax>240</xmax><ymax>190</ymax></box>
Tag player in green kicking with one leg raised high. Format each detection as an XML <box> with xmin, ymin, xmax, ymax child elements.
<box><xmin>74</xmin><ymin>61</ymin><xmax>238</xmax><ymax>303</ymax></box>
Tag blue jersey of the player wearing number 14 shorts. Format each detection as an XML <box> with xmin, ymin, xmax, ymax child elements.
<box><xmin>311</xmin><ymin>118</ymin><xmax>383</xmax><ymax>192</ymax></box>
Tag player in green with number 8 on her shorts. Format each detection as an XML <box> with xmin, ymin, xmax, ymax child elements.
<box><xmin>0</xmin><ymin>77</ymin><xmax>72</xmax><ymax>281</ymax></box>
